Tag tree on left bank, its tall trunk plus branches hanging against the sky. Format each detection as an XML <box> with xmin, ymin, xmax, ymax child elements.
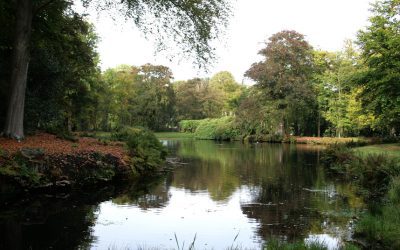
<box><xmin>4</xmin><ymin>0</ymin><xmax>230</xmax><ymax>139</ymax></box>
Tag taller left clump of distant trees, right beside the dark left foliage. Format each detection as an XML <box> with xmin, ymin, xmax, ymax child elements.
<box><xmin>96</xmin><ymin>64</ymin><xmax>175</xmax><ymax>131</ymax></box>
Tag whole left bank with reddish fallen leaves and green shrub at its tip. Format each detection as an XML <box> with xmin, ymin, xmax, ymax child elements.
<box><xmin>0</xmin><ymin>128</ymin><xmax>165</xmax><ymax>197</ymax></box>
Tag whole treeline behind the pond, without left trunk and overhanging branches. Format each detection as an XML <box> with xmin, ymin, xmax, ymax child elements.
<box><xmin>0</xmin><ymin>0</ymin><xmax>400</xmax><ymax>137</ymax></box>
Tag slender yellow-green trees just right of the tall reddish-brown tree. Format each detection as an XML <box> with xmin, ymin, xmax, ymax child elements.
<box><xmin>314</xmin><ymin>40</ymin><xmax>374</xmax><ymax>137</ymax></box>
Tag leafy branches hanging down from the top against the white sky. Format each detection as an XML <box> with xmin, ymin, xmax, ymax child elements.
<box><xmin>83</xmin><ymin>0</ymin><xmax>232</xmax><ymax>67</ymax></box>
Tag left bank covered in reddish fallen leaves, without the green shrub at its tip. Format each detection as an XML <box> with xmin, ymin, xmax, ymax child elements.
<box><xmin>0</xmin><ymin>133</ymin><xmax>132</xmax><ymax>196</ymax></box>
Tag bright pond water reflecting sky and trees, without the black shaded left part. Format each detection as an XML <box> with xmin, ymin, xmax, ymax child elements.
<box><xmin>92</xmin><ymin>141</ymin><xmax>362</xmax><ymax>249</ymax></box>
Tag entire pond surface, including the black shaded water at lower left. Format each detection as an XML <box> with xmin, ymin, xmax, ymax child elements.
<box><xmin>0</xmin><ymin>140</ymin><xmax>363</xmax><ymax>249</ymax></box>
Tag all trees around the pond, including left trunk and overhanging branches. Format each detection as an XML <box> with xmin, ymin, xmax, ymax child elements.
<box><xmin>0</xmin><ymin>0</ymin><xmax>400</xmax><ymax>138</ymax></box>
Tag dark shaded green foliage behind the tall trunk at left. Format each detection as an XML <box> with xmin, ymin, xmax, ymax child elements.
<box><xmin>0</xmin><ymin>1</ymin><xmax>100</xmax><ymax>132</ymax></box>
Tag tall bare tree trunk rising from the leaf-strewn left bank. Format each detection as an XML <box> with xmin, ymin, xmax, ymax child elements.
<box><xmin>4</xmin><ymin>0</ymin><xmax>33</xmax><ymax>140</ymax></box>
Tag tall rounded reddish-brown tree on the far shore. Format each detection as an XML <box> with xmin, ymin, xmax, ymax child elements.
<box><xmin>246</xmin><ymin>31</ymin><xmax>315</xmax><ymax>135</ymax></box>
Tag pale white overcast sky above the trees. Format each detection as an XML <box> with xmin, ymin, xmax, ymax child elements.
<box><xmin>79</xmin><ymin>0</ymin><xmax>373</xmax><ymax>84</ymax></box>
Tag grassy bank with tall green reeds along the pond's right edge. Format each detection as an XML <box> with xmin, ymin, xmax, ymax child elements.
<box><xmin>324</xmin><ymin>144</ymin><xmax>400</xmax><ymax>249</ymax></box>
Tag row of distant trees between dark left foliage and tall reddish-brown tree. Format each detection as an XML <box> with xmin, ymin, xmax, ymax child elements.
<box><xmin>89</xmin><ymin>67</ymin><xmax>245</xmax><ymax>131</ymax></box>
